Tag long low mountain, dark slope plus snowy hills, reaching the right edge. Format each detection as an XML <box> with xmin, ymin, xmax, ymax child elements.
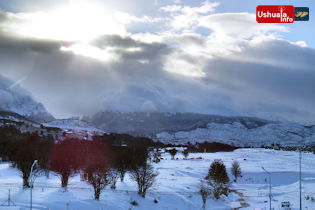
<box><xmin>90</xmin><ymin>111</ymin><xmax>315</xmax><ymax>147</ymax></box>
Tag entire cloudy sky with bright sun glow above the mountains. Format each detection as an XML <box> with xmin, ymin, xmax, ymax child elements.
<box><xmin>0</xmin><ymin>0</ymin><xmax>315</xmax><ymax>123</ymax></box>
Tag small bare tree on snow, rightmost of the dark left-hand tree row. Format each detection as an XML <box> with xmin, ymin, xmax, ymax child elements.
<box><xmin>130</xmin><ymin>163</ymin><xmax>158</xmax><ymax>197</ymax></box>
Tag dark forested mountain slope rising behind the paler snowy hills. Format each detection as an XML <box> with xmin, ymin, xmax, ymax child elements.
<box><xmin>89</xmin><ymin>111</ymin><xmax>270</xmax><ymax>137</ymax></box>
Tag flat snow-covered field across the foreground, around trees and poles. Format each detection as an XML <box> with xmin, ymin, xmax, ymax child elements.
<box><xmin>0</xmin><ymin>149</ymin><xmax>315</xmax><ymax>210</ymax></box>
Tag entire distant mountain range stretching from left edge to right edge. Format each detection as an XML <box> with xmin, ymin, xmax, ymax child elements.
<box><xmin>0</xmin><ymin>76</ymin><xmax>315</xmax><ymax>147</ymax></box>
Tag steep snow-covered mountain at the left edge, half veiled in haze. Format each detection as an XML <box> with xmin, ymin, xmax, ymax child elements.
<box><xmin>0</xmin><ymin>75</ymin><xmax>54</xmax><ymax>122</ymax></box>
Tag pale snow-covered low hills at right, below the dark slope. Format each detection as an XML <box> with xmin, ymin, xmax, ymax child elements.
<box><xmin>155</xmin><ymin>122</ymin><xmax>315</xmax><ymax>147</ymax></box>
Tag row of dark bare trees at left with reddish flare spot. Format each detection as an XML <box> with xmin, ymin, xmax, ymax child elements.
<box><xmin>0</xmin><ymin>127</ymin><xmax>157</xmax><ymax>200</ymax></box>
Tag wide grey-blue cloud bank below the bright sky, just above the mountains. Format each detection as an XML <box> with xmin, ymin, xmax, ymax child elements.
<box><xmin>0</xmin><ymin>28</ymin><xmax>315</xmax><ymax>121</ymax></box>
